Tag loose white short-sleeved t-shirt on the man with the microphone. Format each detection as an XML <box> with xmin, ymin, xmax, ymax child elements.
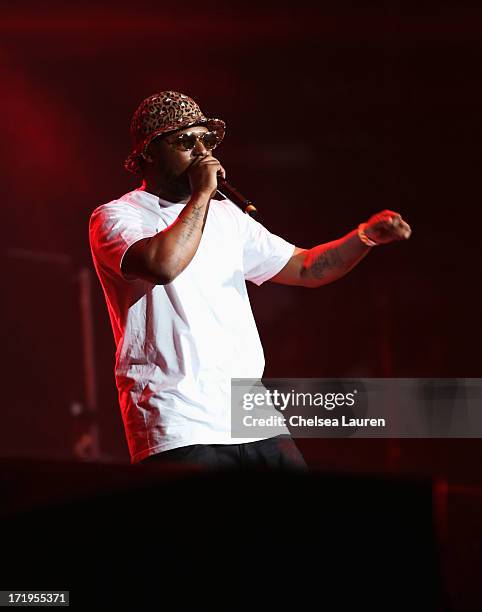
<box><xmin>89</xmin><ymin>189</ymin><xmax>295</xmax><ymax>463</ymax></box>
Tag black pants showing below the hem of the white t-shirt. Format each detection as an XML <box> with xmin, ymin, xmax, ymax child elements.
<box><xmin>141</xmin><ymin>436</ymin><xmax>308</xmax><ymax>472</ymax></box>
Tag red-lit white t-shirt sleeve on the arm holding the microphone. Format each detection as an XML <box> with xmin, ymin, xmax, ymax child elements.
<box><xmin>89</xmin><ymin>202</ymin><xmax>157</xmax><ymax>280</ymax></box>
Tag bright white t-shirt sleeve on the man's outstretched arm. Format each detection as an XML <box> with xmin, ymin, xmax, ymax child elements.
<box><xmin>233</xmin><ymin>204</ymin><xmax>295</xmax><ymax>285</ymax></box>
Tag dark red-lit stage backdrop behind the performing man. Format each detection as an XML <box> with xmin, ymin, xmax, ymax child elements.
<box><xmin>0</xmin><ymin>0</ymin><xmax>482</xmax><ymax>464</ymax></box>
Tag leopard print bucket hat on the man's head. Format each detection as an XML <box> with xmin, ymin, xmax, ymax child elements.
<box><xmin>124</xmin><ymin>91</ymin><xmax>226</xmax><ymax>174</ymax></box>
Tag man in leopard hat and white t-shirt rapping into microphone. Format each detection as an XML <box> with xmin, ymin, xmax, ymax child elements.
<box><xmin>89</xmin><ymin>91</ymin><xmax>411</xmax><ymax>470</ymax></box>
